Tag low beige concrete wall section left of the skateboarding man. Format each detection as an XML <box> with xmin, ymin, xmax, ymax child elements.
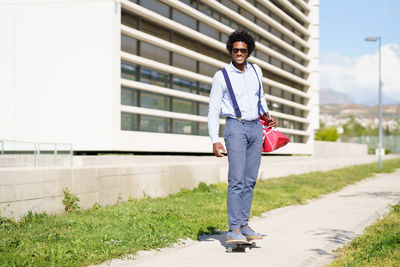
<box><xmin>0</xmin><ymin>162</ymin><xmax>220</xmax><ymax>218</ymax></box>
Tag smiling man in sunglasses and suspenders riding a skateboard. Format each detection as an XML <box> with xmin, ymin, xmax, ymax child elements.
<box><xmin>208</xmin><ymin>30</ymin><xmax>278</xmax><ymax>243</ymax></box>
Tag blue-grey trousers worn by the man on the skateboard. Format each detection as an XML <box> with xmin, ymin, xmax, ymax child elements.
<box><xmin>224</xmin><ymin>118</ymin><xmax>263</xmax><ymax>230</ymax></box>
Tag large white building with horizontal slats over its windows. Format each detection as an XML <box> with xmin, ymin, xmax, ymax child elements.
<box><xmin>0</xmin><ymin>0</ymin><xmax>319</xmax><ymax>154</ymax></box>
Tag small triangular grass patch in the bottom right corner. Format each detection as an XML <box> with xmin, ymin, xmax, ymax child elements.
<box><xmin>329</xmin><ymin>202</ymin><xmax>400</xmax><ymax>267</ymax></box>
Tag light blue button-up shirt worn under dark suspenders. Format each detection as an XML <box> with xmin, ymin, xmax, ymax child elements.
<box><xmin>208</xmin><ymin>62</ymin><xmax>268</xmax><ymax>144</ymax></box>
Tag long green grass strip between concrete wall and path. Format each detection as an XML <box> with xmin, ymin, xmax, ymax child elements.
<box><xmin>0</xmin><ymin>158</ymin><xmax>400</xmax><ymax>266</ymax></box>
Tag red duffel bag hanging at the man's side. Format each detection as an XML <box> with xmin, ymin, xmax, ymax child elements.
<box><xmin>260</xmin><ymin>116</ymin><xmax>289</xmax><ymax>152</ymax></box>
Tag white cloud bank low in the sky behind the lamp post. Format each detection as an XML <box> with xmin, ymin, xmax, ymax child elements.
<box><xmin>320</xmin><ymin>44</ymin><xmax>400</xmax><ymax>104</ymax></box>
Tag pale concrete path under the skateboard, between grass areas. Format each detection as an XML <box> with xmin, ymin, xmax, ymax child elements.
<box><xmin>97</xmin><ymin>170</ymin><xmax>400</xmax><ymax>267</ymax></box>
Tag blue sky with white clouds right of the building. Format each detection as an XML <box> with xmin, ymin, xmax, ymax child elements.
<box><xmin>319</xmin><ymin>0</ymin><xmax>400</xmax><ymax>104</ymax></box>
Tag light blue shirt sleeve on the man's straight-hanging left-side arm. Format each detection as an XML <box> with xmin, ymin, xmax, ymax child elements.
<box><xmin>208</xmin><ymin>71</ymin><xmax>223</xmax><ymax>144</ymax></box>
